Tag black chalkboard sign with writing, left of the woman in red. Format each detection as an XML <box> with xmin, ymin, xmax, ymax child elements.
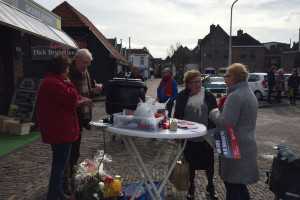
<box><xmin>9</xmin><ymin>78</ymin><xmax>41</xmax><ymax>122</ymax></box>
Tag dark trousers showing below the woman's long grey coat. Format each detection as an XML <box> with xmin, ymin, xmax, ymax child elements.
<box><xmin>224</xmin><ymin>182</ymin><xmax>250</xmax><ymax>200</ymax></box>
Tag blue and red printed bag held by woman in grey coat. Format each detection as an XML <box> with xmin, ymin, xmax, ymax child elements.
<box><xmin>208</xmin><ymin>125</ymin><xmax>241</xmax><ymax>159</ymax></box>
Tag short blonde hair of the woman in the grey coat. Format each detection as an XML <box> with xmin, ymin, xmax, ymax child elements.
<box><xmin>226</xmin><ymin>63</ymin><xmax>249</xmax><ymax>84</ymax></box>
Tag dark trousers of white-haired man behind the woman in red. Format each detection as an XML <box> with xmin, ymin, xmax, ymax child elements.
<box><xmin>64</xmin><ymin>131</ymin><xmax>81</xmax><ymax>184</ymax></box>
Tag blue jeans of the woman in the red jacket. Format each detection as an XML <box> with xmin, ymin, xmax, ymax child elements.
<box><xmin>47</xmin><ymin>143</ymin><xmax>72</xmax><ymax>200</ymax></box>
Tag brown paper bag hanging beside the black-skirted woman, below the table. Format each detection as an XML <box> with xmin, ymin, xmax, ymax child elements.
<box><xmin>168</xmin><ymin>152</ymin><xmax>190</xmax><ymax>191</ymax></box>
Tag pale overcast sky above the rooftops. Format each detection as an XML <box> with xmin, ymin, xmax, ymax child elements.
<box><xmin>35</xmin><ymin>0</ymin><xmax>300</xmax><ymax>59</ymax></box>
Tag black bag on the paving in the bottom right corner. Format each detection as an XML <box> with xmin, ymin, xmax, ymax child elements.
<box><xmin>269</xmin><ymin>157</ymin><xmax>300</xmax><ymax>200</ymax></box>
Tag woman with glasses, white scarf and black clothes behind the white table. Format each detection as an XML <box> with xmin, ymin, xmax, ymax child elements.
<box><xmin>174</xmin><ymin>70</ymin><xmax>218</xmax><ymax>200</ymax></box>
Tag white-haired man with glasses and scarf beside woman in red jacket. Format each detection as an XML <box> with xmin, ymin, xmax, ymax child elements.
<box><xmin>64</xmin><ymin>49</ymin><xmax>102</xmax><ymax>193</ymax></box>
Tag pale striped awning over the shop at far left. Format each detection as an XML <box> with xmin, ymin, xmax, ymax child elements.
<box><xmin>0</xmin><ymin>1</ymin><xmax>78</xmax><ymax>49</ymax></box>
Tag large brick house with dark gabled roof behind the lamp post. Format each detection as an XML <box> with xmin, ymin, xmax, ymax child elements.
<box><xmin>198</xmin><ymin>24</ymin><xmax>265</xmax><ymax>75</ymax></box>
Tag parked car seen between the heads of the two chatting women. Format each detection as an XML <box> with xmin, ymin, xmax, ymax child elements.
<box><xmin>202</xmin><ymin>76</ymin><xmax>226</xmax><ymax>92</ymax></box>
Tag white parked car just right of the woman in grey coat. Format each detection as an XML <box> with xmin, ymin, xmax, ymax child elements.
<box><xmin>248</xmin><ymin>73</ymin><xmax>277</xmax><ymax>100</ymax></box>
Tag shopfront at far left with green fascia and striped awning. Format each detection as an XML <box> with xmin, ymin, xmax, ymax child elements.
<box><xmin>0</xmin><ymin>0</ymin><xmax>78</xmax><ymax>115</ymax></box>
